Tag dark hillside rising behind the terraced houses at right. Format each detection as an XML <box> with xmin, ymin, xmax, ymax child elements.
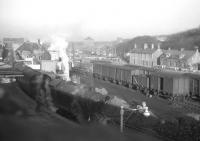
<box><xmin>116</xmin><ymin>28</ymin><xmax>200</xmax><ymax>57</ymax></box>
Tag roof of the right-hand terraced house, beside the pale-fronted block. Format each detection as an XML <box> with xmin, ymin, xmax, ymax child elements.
<box><xmin>163</xmin><ymin>50</ymin><xmax>195</xmax><ymax>60</ymax></box>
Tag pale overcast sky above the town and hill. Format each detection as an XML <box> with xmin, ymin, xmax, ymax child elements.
<box><xmin>0</xmin><ymin>0</ymin><xmax>200</xmax><ymax>40</ymax></box>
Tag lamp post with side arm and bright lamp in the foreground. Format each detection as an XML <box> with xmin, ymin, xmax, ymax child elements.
<box><xmin>120</xmin><ymin>102</ymin><xmax>150</xmax><ymax>133</ymax></box>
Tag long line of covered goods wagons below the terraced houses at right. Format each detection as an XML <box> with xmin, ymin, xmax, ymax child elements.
<box><xmin>94</xmin><ymin>60</ymin><xmax>200</xmax><ymax>97</ymax></box>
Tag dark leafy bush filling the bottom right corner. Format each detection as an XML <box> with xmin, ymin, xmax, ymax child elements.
<box><xmin>154</xmin><ymin>117</ymin><xmax>200</xmax><ymax>141</ymax></box>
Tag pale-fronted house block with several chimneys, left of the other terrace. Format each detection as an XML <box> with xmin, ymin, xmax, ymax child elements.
<box><xmin>130</xmin><ymin>44</ymin><xmax>163</xmax><ymax>67</ymax></box>
